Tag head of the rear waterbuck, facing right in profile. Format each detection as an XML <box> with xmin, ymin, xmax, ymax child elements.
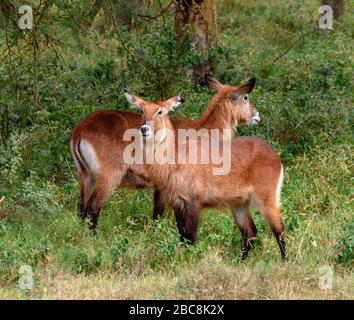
<box><xmin>204</xmin><ymin>74</ymin><xmax>261</xmax><ymax>125</ymax></box>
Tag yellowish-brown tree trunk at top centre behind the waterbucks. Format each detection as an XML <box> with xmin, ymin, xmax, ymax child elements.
<box><xmin>175</xmin><ymin>0</ymin><xmax>218</xmax><ymax>81</ymax></box>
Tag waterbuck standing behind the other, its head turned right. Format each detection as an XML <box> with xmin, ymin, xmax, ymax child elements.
<box><xmin>70</xmin><ymin>75</ymin><xmax>260</xmax><ymax>229</ymax></box>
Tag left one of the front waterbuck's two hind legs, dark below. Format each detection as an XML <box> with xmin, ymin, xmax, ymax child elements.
<box><xmin>233</xmin><ymin>205</ymin><xmax>257</xmax><ymax>259</ymax></box>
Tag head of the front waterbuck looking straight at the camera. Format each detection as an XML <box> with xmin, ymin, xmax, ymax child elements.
<box><xmin>124</xmin><ymin>92</ymin><xmax>183</xmax><ymax>139</ymax></box>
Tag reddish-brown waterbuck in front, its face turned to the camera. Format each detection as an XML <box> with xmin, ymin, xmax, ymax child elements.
<box><xmin>131</xmin><ymin>94</ymin><xmax>287</xmax><ymax>260</ymax></box>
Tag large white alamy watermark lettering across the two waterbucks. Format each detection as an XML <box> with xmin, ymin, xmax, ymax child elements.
<box><xmin>123</xmin><ymin>127</ymin><xmax>232</xmax><ymax>175</ymax></box>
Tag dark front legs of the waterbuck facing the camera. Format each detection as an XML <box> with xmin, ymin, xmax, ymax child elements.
<box><xmin>173</xmin><ymin>201</ymin><xmax>200</xmax><ymax>244</ymax></box>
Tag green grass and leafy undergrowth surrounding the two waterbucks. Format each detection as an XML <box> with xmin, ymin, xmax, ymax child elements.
<box><xmin>0</xmin><ymin>0</ymin><xmax>354</xmax><ymax>299</ymax></box>
